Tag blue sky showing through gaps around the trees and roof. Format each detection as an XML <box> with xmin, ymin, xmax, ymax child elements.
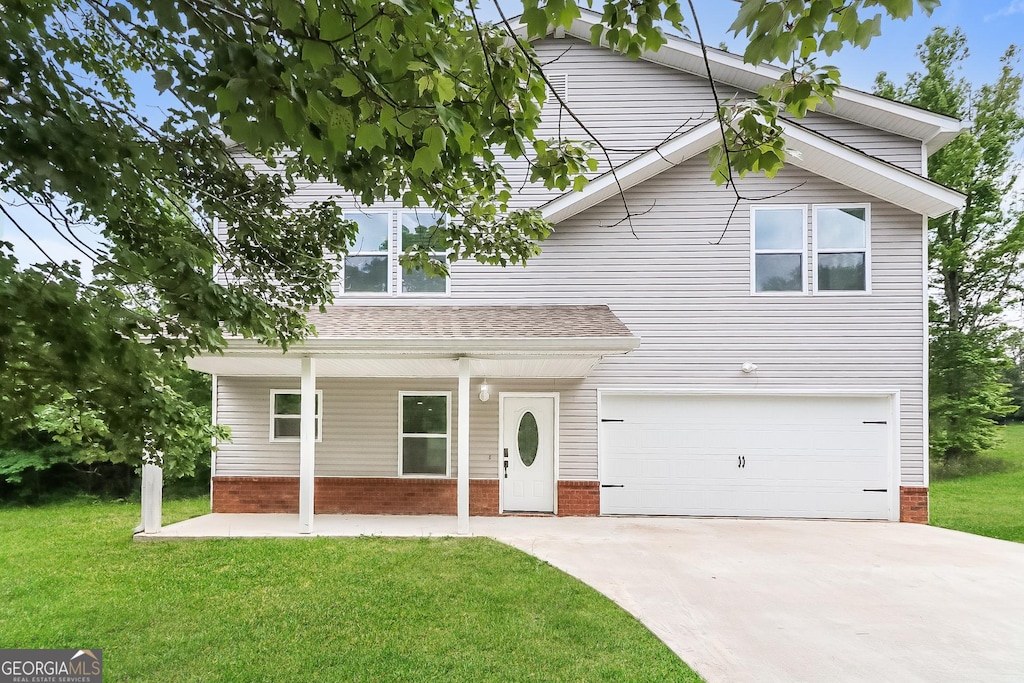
<box><xmin>0</xmin><ymin>0</ymin><xmax>1024</xmax><ymax>269</ymax></box>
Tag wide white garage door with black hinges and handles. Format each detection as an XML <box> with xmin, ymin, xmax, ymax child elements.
<box><xmin>599</xmin><ymin>393</ymin><xmax>894</xmax><ymax>519</ymax></box>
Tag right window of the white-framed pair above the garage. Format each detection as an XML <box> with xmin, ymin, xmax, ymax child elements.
<box><xmin>814</xmin><ymin>204</ymin><xmax>870</xmax><ymax>292</ymax></box>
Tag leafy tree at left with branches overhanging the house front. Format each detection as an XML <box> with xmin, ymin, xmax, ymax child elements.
<box><xmin>0</xmin><ymin>0</ymin><xmax>938</xmax><ymax>475</ymax></box>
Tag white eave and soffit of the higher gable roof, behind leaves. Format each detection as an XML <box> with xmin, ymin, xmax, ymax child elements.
<box><xmin>512</xmin><ymin>8</ymin><xmax>970</xmax><ymax>155</ymax></box>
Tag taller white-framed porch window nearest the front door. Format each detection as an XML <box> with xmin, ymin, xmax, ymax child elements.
<box><xmin>398</xmin><ymin>391</ymin><xmax>452</xmax><ymax>476</ymax></box>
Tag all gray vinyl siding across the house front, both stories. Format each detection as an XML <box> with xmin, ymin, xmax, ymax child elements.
<box><xmin>217</xmin><ymin>39</ymin><xmax>926</xmax><ymax>485</ymax></box>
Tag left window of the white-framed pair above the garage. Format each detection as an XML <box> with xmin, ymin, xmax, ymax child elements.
<box><xmin>751</xmin><ymin>206</ymin><xmax>807</xmax><ymax>293</ymax></box>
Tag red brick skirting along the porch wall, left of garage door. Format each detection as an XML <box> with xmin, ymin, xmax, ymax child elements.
<box><xmin>213</xmin><ymin>477</ymin><xmax>601</xmax><ymax>516</ymax></box>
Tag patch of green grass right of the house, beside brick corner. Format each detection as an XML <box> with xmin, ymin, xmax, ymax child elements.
<box><xmin>930</xmin><ymin>424</ymin><xmax>1024</xmax><ymax>543</ymax></box>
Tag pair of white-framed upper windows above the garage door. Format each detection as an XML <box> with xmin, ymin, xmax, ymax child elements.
<box><xmin>751</xmin><ymin>204</ymin><xmax>871</xmax><ymax>294</ymax></box>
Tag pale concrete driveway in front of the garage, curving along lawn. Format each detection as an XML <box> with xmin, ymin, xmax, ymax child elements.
<box><xmin>473</xmin><ymin>517</ymin><xmax>1024</xmax><ymax>683</ymax></box>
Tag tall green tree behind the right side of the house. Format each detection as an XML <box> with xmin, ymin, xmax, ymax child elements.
<box><xmin>877</xmin><ymin>28</ymin><xmax>1024</xmax><ymax>462</ymax></box>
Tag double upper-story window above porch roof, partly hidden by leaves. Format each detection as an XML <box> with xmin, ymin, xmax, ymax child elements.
<box><xmin>340</xmin><ymin>209</ymin><xmax>449</xmax><ymax>296</ymax></box>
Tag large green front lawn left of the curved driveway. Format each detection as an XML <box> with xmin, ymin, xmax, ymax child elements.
<box><xmin>0</xmin><ymin>499</ymin><xmax>699</xmax><ymax>683</ymax></box>
